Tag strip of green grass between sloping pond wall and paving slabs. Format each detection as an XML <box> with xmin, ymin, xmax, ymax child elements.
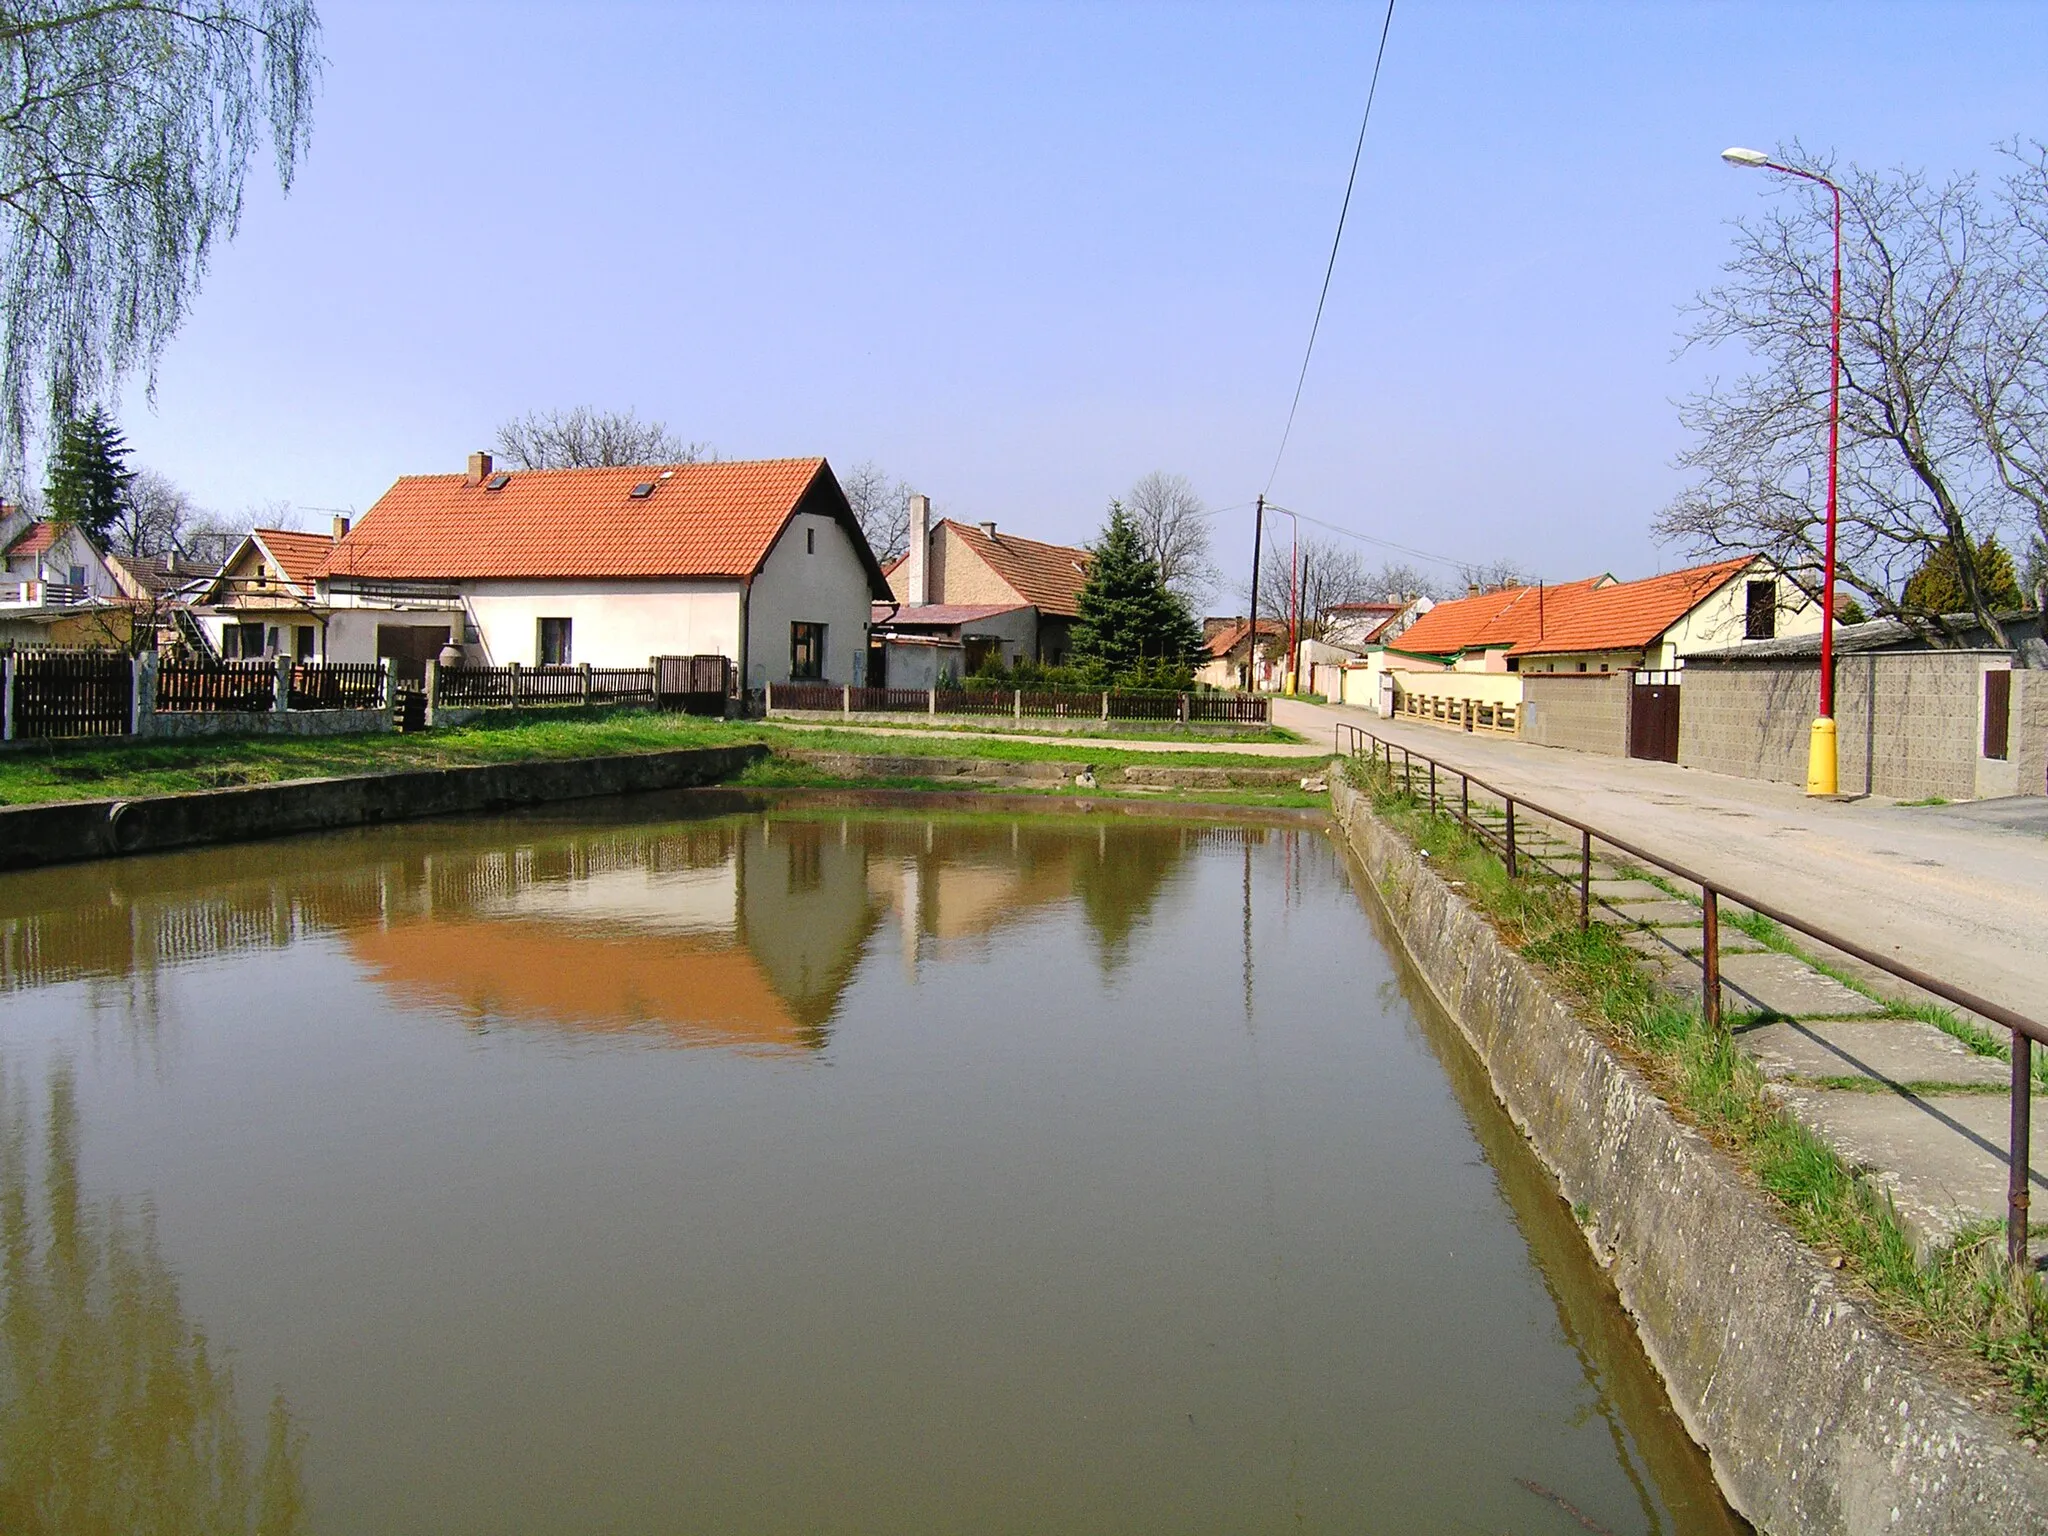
<box><xmin>1346</xmin><ymin>760</ymin><xmax>2048</xmax><ymax>1434</ymax></box>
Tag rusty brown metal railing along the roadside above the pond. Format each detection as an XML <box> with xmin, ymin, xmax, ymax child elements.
<box><xmin>1331</xmin><ymin>723</ymin><xmax>2048</xmax><ymax>1270</ymax></box>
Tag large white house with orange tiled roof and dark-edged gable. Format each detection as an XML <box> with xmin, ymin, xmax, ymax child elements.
<box><xmin>315</xmin><ymin>453</ymin><xmax>889</xmax><ymax>688</ymax></box>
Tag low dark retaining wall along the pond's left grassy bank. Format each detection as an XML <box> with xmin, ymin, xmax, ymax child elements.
<box><xmin>0</xmin><ymin>745</ymin><xmax>768</xmax><ymax>868</ymax></box>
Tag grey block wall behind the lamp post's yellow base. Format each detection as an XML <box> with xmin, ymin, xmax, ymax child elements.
<box><xmin>1677</xmin><ymin>651</ymin><xmax>2048</xmax><ymax>801</ymax></box>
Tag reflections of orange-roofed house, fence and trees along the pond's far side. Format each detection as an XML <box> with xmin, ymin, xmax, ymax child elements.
<box><xmin>0</xmin><ymin>813</ymin><xmax>1268</xmax><ymax>1053</ymax></box>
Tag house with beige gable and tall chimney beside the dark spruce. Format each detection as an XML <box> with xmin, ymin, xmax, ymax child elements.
<box><xmin>883</xmin><ymin>496</ymin><xmax>1090</xmax><ymax>666</ymax></box>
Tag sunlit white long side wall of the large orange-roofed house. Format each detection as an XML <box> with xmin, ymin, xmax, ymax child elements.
<box><xmin>460</xmin><ymin>580</ymin><xmax>749</xmax><ymax>668</ymax></box>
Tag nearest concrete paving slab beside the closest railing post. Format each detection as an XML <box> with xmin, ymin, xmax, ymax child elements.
<box><xmin>1778</xmin><ymin>1087</ymin><xmax>2048</xmax><ymax>1255</ymax></box>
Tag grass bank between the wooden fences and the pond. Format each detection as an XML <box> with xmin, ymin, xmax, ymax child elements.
<box><xmin>0</xmin><ymin>711</ymin><xmax>1319</xmax><ymax>805</ymax></box>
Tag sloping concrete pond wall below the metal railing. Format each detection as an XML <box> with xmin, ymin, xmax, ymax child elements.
<box><xmin>1331</xmin><ymin>776</ymin><xmax>2048</xmax><ymax>1536</ymax></box>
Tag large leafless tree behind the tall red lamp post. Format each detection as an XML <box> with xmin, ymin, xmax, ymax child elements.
<box><xmin>1655</xmin><ymin>145</ymin><xmax>2015</xmax><ymax>643</ymax></box>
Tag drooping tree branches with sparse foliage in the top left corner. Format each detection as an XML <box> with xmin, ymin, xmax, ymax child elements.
<box><xmin>0</xmin><ymin>0</ymin><xmax>322</xmax><ymax>463</ymax></box>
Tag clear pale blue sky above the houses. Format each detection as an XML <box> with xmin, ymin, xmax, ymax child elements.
<box><xmin>108</xmin><ymin>0</ymin><xmax>2048</xmax><ymax>606</ymax></box>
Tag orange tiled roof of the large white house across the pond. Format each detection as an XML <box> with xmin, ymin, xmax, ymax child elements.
<box><xmin>319</xmin><ymin>459</ymin><xmax>856</xmax><ymax>580</ymax></box>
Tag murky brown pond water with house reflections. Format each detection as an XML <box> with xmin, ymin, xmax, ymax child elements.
<box><xmin>0</xmin><ymin>795</ymin><xmax>1741</xmax><ymax>1534</ymax></box>
